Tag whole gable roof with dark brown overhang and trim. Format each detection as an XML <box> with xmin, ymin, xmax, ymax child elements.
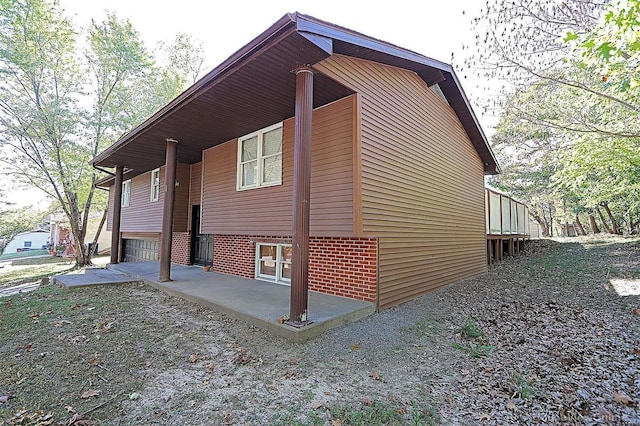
<box><xmin>91</xmin><ymin>12</ymin><xmax>499</xmax><ymax>181</ymax></box>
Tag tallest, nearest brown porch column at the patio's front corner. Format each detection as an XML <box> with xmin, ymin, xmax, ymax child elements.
<box><xmin>289</xmin><ymin>67</ymin><xmax>313</xmax><ymax>326</ymax></box>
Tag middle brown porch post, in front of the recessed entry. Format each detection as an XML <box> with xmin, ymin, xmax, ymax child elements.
<box><xmin>158</xmin><ymin>138</ymin><xmax>178</xmax><ymax>282</ymax></box>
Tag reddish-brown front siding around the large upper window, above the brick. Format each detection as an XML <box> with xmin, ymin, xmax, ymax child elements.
<box><xmin>202</xmin><ymin>97</ymin><xmax>354</xmax><ymax>237</ymax></box>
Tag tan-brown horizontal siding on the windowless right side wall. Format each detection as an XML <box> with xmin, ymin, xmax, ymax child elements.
<box><xmin>314</xmin><ymin>55</ymin><xmax>486</xmax><ymax>309</ymax></box>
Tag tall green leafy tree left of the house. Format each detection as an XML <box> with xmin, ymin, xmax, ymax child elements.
<box><xmin>0</xmin><ymin>0</ymin><xmax>204</xmax><ymax>265</ymax></box>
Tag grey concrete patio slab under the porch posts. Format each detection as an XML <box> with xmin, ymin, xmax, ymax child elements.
<box><xmin>107</xmin><ymin>262</ymin><xmax>375</xmax><ymax>342</ymax></box>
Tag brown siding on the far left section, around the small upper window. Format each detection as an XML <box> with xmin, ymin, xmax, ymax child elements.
<box><xmin>107</xmin><ymin>163</ymin><xmax>191</xmax><ymax>233</ymax></box>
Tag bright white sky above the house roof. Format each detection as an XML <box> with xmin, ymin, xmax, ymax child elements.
<box><xmin>0</xmin><ymin>0</ymin><xmax>494</xmax><ymax>206</ymax></box>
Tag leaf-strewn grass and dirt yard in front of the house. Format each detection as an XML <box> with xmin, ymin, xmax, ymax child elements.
<box><xmin>0</xmin><ymin>238</ymin><xmax>640</xmax><ymax>425</ymax></box>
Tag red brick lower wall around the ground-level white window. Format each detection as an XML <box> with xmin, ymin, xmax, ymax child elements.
<box><xmin>213</xmin><ymin>235</ymin><xmax>378</xmax><ymax>302</ymax></box>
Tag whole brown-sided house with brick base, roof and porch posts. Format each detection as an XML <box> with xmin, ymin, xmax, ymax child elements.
<box><xmin>92</xmin><ymin>13</ymin><xmax>498</xmax><ymax>316</ymax></box>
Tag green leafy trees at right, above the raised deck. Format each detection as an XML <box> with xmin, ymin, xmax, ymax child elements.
<box><xmin>466</xmin><ymin>0</ymin><xmax>640</xmax><ymax>233</ymax></box>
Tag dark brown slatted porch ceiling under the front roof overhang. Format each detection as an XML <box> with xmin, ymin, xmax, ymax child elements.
<box><xmin>93</xmin><ymin>27</ymin><xmax>353</xmax><ymax>173</ymax></box>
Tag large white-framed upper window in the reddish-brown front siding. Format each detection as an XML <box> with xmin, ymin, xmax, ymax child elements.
<box><xmin>236</xmin><ymin>123</ymin><xmax>282</xmax><ymax>190</ymax></box>
